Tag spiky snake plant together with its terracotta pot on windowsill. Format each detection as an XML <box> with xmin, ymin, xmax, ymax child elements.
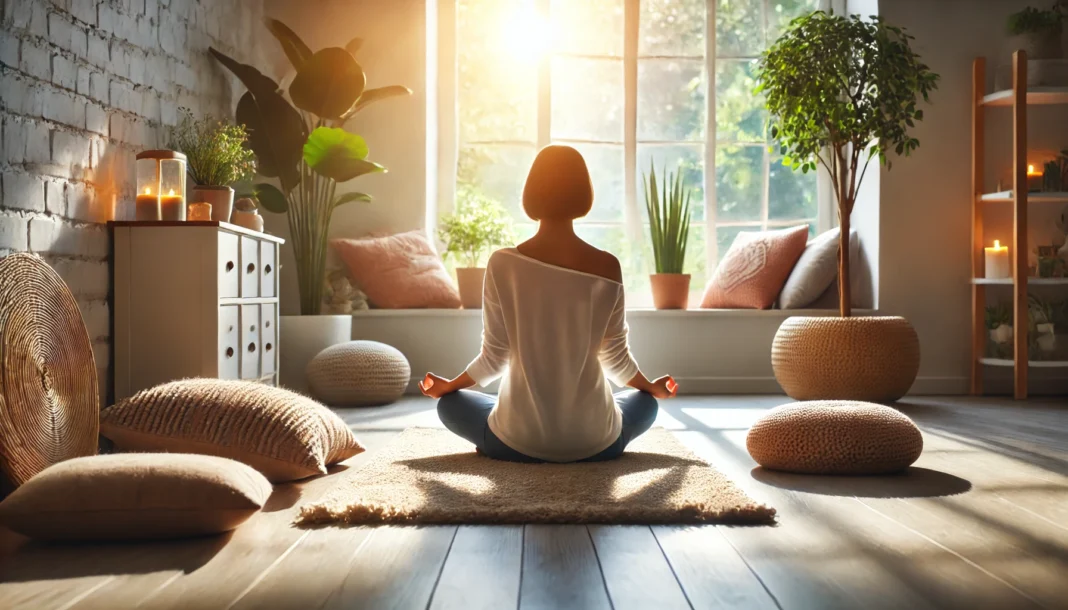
<box><xmin>642</xmin><ymin>161</ymin><xmax>692</xmax><ymax>309</ymax></box>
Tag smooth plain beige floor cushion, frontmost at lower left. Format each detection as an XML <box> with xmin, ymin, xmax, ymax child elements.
<box><xmin>0</xmin><ymin>453</ymin><xmax>271</xmax><ymax>541</ymax></box>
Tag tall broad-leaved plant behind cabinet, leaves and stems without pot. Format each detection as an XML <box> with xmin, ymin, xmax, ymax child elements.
<box><xmin>210</xmin><ymin>19</ymin><xmax>411</xmax><ymax>315</ymax></box>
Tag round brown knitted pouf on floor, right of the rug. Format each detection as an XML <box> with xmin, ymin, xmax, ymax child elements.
<box><xmin>745</xmin><ymin>401</ymin><xmax>924</xmax><ymax>474</ymax></box>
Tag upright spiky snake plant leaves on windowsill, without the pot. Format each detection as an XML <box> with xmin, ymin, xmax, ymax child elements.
<box><xmin>642</xmin><ymin>161</ymin><xmax>692</xmax><ymax>273</ymax></box>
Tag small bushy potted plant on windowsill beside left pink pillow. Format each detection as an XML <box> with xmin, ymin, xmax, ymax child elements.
<box><xmin>438</xmin><ymin>186</ymin><xmax>515</xmax><ymax>309</ymax></box>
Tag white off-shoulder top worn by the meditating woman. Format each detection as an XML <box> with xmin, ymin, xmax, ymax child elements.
<box><xmin>467</xmin><ymin>248</ymin><xmax>639</xmax><ymax>462</ymax></box>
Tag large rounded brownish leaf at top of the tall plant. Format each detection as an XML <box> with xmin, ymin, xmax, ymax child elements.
<box><xmin>289</xmin><ymin>47</ymin><xmax>367</xmax><ymax>119</ymax></box>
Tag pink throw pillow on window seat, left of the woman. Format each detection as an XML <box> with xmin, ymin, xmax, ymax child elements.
<box><xmin>330</xmin><ymin>230</ymin><xmax>460</xmax><ymax>309</ymax></box>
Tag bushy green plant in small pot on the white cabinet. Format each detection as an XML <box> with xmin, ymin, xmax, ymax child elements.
<box><xmin>170</xmin><ymin>109</ymin><xmax>256</xmax><ymax>222</ymax></box>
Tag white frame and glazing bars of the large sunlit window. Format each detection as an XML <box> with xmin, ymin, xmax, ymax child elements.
<box><xmin>426</xmin><ymin>0</ymin><xmax>847</xmax><ymax>291</ymax></box>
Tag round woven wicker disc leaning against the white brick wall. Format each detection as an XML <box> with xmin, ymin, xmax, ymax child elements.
<box><xmin>0</xmin><ymin>253</ymin><xmax>100</xmax><ymax>487</ymax></box>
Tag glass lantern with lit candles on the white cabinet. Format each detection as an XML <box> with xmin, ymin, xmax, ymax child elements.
<box><xmin>135</xmin><ymin>151</ymin><xmax>186</xmax><ymax>220</ymax></box>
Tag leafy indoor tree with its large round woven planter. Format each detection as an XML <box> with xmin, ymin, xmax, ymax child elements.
<box><xmin>757</xmin><ymin>11</ymin><xmax>939</xmax><ymax>402</ymax></box>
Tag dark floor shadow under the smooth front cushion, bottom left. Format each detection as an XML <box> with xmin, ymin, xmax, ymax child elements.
<box><xmin>0</xmin><ymin>532</ymin><xmax>233</xmax><ymax>581</ymax></box>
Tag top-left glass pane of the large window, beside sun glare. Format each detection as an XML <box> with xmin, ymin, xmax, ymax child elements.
<box><xmin>456</xmin><ymin>0</ymin><xmax>537</xmax><ymax>142</ymax></box>
